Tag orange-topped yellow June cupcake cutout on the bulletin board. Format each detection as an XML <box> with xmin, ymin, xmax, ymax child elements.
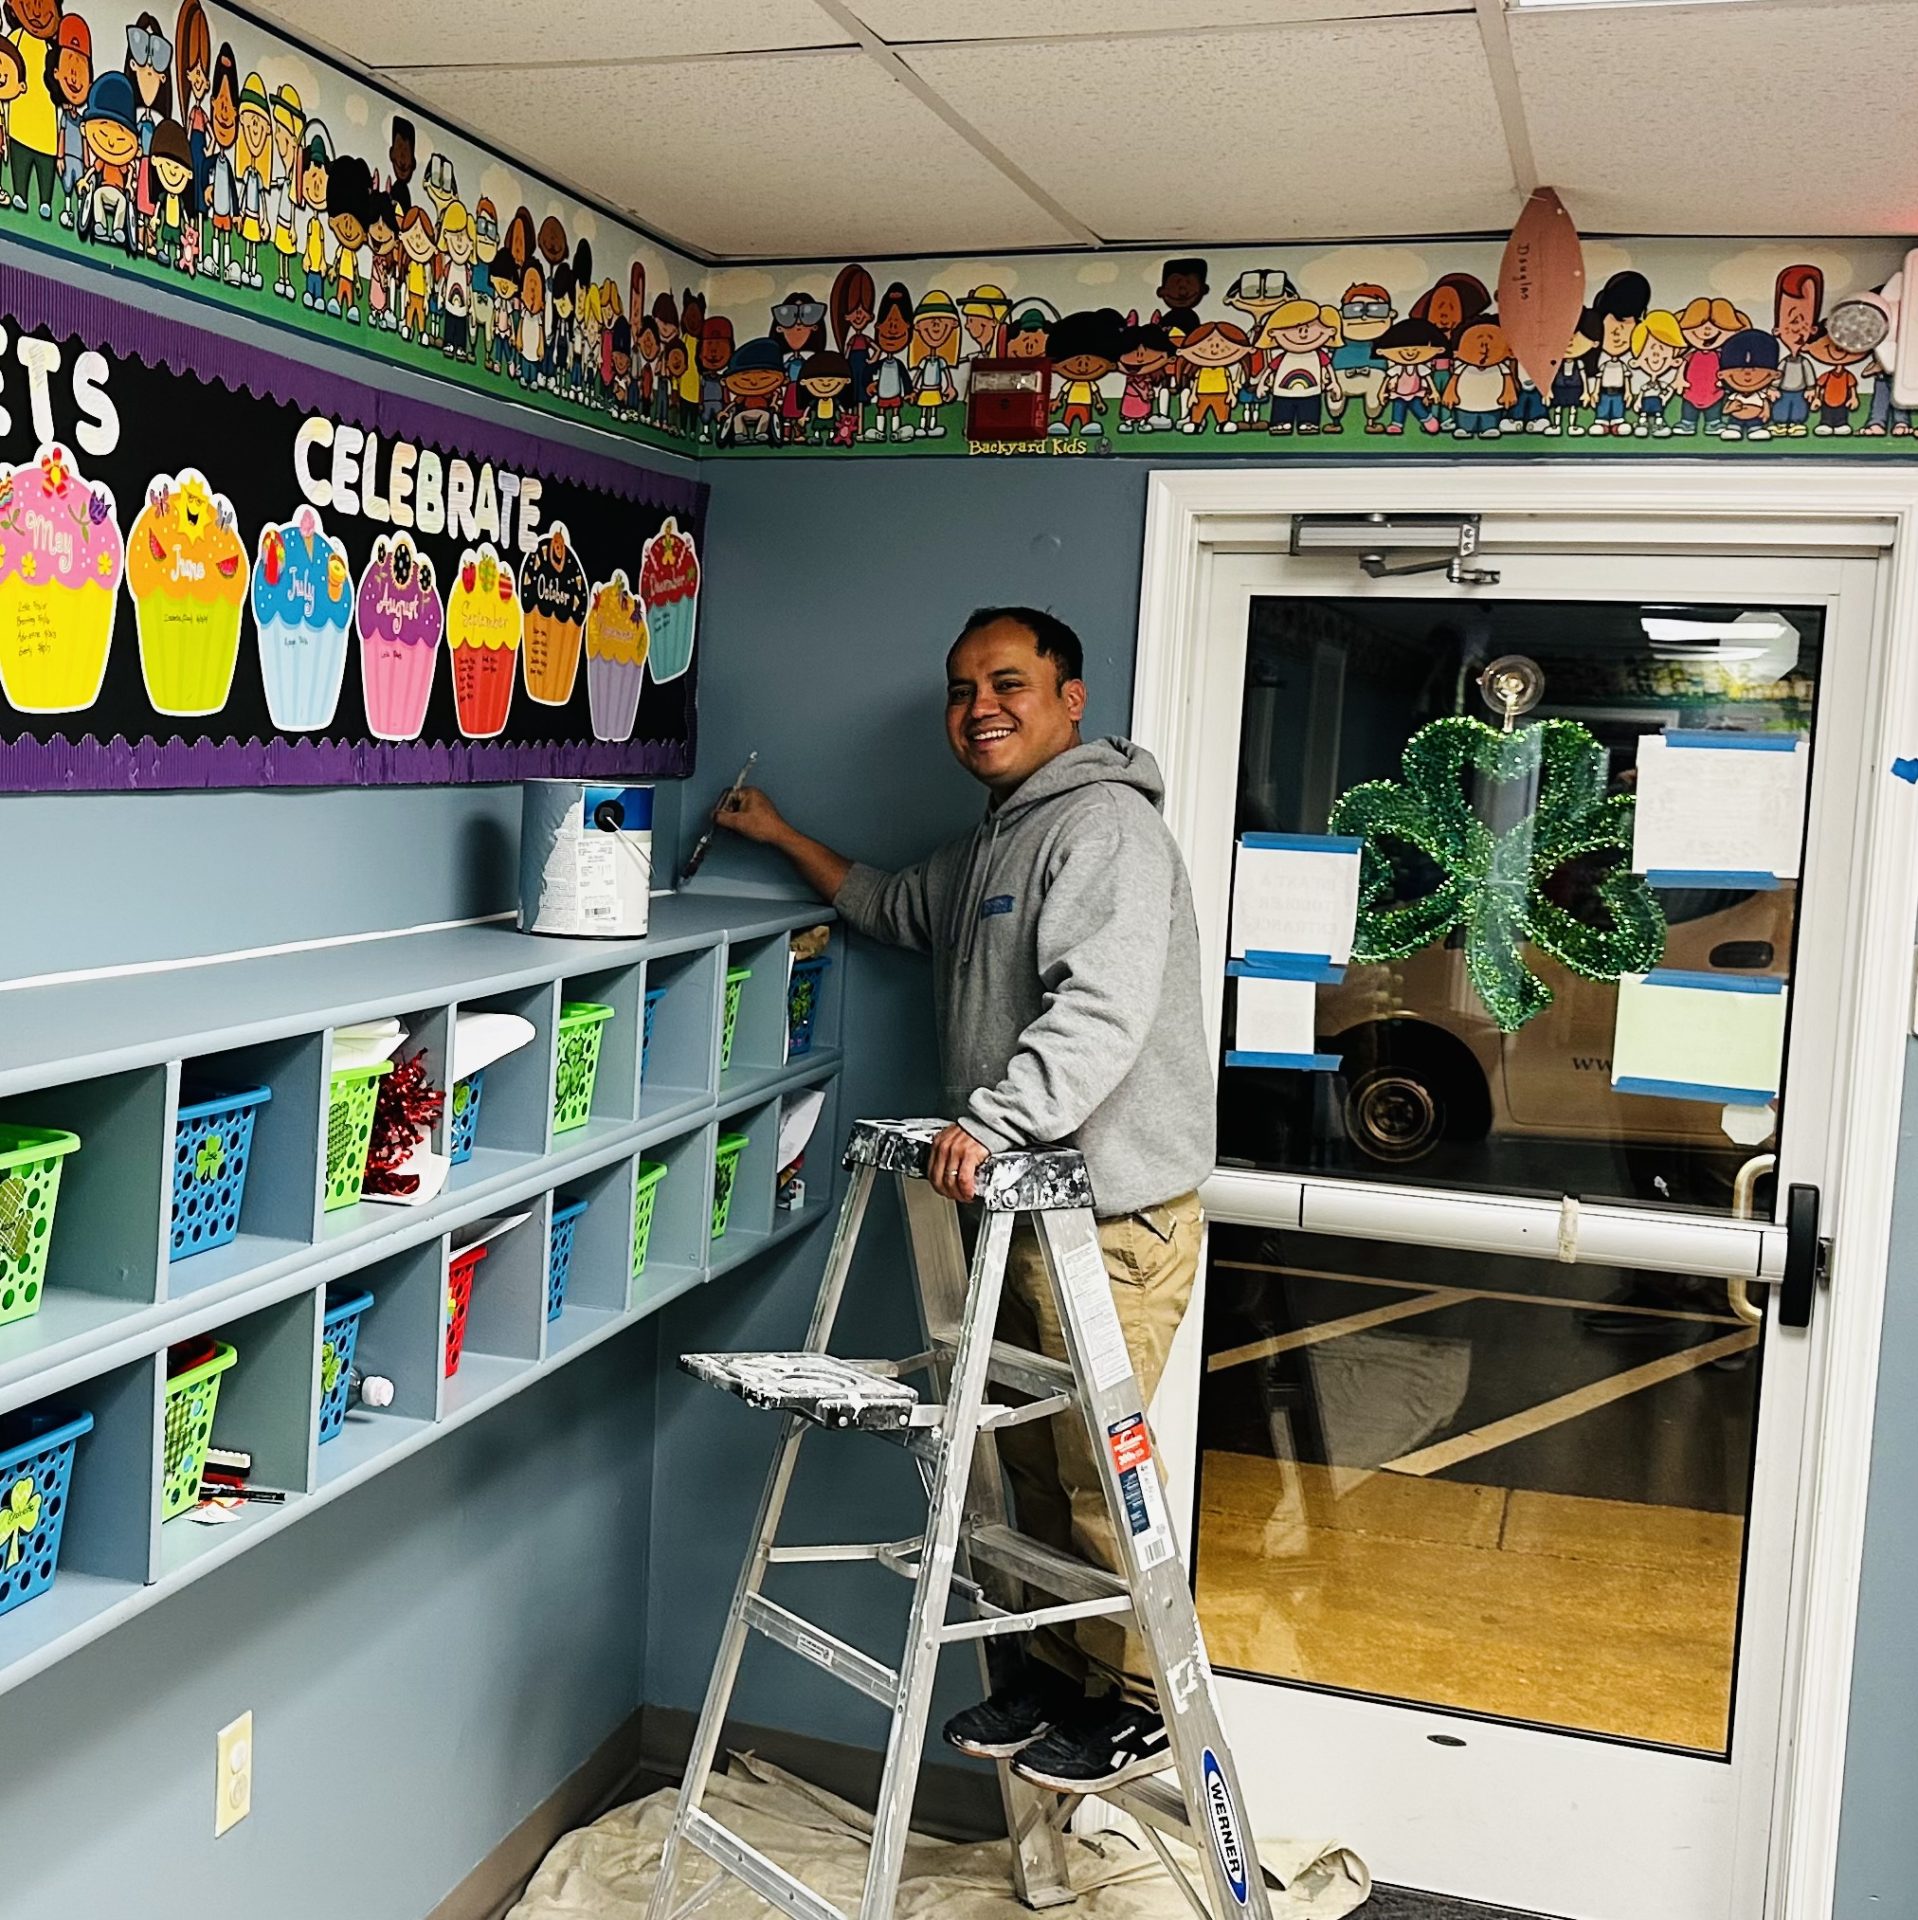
<box><xmin>127</xmin><ymin>467</ymin><xmax>248</xmax><ymax>718</ymax></box>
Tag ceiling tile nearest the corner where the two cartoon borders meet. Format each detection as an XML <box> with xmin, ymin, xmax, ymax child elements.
<box><xmin>388</xmin><ymin>52</ymin><xmax>1073</xmax><ymax>259</ymax></box>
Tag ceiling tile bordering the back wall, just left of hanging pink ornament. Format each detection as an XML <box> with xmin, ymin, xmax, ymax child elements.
<box><xmin>906</xmin><ymin>15</ymin><xmax>1519</xmax><ymax>240</ymax></box>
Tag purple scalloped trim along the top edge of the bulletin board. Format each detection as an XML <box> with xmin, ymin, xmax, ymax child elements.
<box><xmin>0</xmin><ymin>255</ymin><xmax>707</xmax><ymax>518</ymax></box>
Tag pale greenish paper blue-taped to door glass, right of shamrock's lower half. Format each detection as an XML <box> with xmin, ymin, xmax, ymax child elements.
<box><xmin>1611</xmin><ymin>968</ymin><xmax>1789</xmax><ymax>1106</ymax></box>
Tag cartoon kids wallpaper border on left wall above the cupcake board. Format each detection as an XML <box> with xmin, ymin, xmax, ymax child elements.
<box><xmin>0</xmin><ymin>0</ymin><xmax>703</xmax><ymax>456</ymax></box>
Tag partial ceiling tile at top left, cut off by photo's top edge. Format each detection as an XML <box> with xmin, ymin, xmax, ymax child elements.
<box><xmin>267</xmin><ymin>0</ymin><xmax>849</xmax><ymax>67</ymax></box>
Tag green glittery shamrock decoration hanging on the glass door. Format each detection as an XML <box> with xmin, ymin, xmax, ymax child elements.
<box><xmin>1331</xmin><ymin>714</ymin><xmax>1665</xmax><ymax>1033</ymax></box>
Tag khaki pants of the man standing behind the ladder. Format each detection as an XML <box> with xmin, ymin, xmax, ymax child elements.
<box><xmin>998</xmin><ymin>1194</ymin><xmax>1202</xmax><ymax>1701</ymax></box>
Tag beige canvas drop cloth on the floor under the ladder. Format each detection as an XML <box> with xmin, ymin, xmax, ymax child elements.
<box><xmin>507</xmin><ymin>1753</ymin><xmax>1371</xmax><ymax>1920</ymax></box>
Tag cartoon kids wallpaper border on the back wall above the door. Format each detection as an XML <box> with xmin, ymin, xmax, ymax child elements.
<box><xmin>699</xmin><ymin>240</ymin><xmax>1914</xmax><ymax>459</ymax></box>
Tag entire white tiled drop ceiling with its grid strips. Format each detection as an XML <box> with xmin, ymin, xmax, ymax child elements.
<box><xmin>247</xmin><ymin>0</ymin><xmax>1918</xmax><ymax>261</ymax></box>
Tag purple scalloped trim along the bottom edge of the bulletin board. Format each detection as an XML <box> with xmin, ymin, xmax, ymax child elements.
<box><xmin>0</xmin><ymin>733</ymin><xmax>693</xmax><ymax>793</ymax></box>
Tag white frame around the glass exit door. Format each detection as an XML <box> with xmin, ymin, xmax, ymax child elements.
<box><xmin>1133</xmin><ymin>461</ymin><xmax>1918</xmax><ymax>1920</ymax></box>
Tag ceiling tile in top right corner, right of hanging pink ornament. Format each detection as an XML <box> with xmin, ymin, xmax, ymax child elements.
<box><xmin>1511</xmin><ymin>0</ymin><xmax>1918</xmax><ymax>234</ymax></box>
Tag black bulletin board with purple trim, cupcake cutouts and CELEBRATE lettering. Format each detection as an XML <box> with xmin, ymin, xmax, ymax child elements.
<box><xmin>0</xmin><ymin>259</ymin><xmax>707</xmax><ymax>791</ymax></box>
